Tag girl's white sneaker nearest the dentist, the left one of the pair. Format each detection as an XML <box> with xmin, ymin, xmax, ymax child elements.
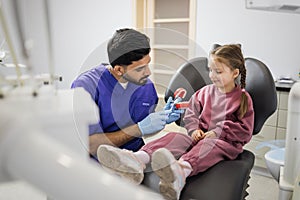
<box><xmin>97</xmin><ymin>145</ymin><xmax>145</xmax><ymax>185</ymax></box>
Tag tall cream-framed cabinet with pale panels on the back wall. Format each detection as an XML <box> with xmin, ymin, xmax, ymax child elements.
<box><xmin>135</xmin><ymin>0</ymin><xmax>196</xmax><ymax>97</ymax></box>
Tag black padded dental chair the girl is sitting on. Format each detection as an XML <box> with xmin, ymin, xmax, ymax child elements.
<box><xmin>143</xmin><ymin>57</ymin><xmax>277</xmax><ymax>200</ymax></box>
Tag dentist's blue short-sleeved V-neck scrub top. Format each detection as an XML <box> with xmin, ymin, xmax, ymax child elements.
<box><xmin>71</xmin><ymin>64</ymin><xmax>158</xmax><ymax>151</ymax></box>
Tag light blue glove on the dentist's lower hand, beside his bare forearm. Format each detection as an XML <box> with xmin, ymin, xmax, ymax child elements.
<box><xmin>138</xmin><ymin>110</ymin><xmax>171</xmax><ymax>136</ymax></box>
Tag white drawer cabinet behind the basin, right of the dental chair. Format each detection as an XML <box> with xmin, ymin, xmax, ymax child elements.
<box><xmin>245</xmin><ymin>87</ymin><xmax>289</xmax><ymax>168</ymax></box>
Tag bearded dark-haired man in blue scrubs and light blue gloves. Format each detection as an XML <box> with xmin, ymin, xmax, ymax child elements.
<box><xmin>71</xmin><ymin>28</ymin><xmax>181</xmax><ymax>159</ymax></box>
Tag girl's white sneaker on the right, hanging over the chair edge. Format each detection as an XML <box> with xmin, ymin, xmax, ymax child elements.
<box><xmin>151</xmin><ymin>148</ymin><xmax>186</xmax><ymax>200</ymax></box>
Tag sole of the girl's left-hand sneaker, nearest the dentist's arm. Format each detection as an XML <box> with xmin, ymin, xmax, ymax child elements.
<box><xmin>97</xmin><ymin>146</ymin><xmax>144</xmax><ymax>185</ymax></box>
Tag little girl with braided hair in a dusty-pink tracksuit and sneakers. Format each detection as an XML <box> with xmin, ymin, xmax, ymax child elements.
<box><xmin>97</xmin><ymin>44</ymin><xmax>254</xmax><ymax>199</ymax></box>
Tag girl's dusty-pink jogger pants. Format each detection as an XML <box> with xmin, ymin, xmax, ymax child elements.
<box><xmin>141</xmin><ymin>132</ymin><xmax>243</xmax><ymax>176</ymax></box>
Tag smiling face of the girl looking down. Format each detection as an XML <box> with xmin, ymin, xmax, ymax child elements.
<box><xmin>208</xmin><ymin>56</ymin><xmax>240</xmax><ymax>93</ymax></box>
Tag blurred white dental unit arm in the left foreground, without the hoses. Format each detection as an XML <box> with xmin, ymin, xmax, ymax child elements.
<box><xmin>0</xmin><ymin>86</ymin><xmax>161</xmax><ymax>200</ymax></box>
